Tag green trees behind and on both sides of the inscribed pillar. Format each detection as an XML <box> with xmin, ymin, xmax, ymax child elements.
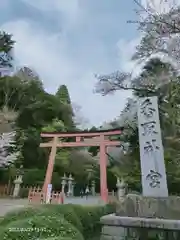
<box><xmin>96</xmin><ymin>53</ymin><xmax>180</xmax><ymax>194</ymax></box>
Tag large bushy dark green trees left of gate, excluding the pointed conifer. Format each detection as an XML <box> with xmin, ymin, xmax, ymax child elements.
<box><xmin>0</xmin><ymin>60</ymin><xmax>73</xmax><ymax>174</ymax></box>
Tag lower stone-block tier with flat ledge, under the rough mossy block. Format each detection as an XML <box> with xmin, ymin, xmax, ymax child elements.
<box><xmin>100</xmin><ymin>214</ymin><xmax>180</xmax><ymax>240</ymax></box>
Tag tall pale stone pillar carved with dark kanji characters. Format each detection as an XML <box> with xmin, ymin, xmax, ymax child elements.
<box><xmin>138</xmin><ymin>96</ymin><xmax>168</xmax><ymax>197</ymax></box>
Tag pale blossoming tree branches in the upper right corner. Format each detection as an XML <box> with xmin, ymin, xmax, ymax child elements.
<box><xmin>132</xmin><ymin>0</ymin><xmax>180</xmax><ymax>66</ymax></box>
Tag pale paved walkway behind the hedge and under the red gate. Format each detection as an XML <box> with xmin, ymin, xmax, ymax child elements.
<box><xmin>0</xmin><ymin>197</ymin><xmax>103</xmax><ymax>217</ymax></box>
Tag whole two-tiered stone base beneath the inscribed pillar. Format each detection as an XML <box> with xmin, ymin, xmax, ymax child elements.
<box><xmin>101</xmin><ymin>194</ymin><xmax>180</xmax><ymax>240</ymax></box>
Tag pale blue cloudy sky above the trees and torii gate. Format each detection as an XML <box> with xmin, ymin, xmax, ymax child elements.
<box><xmin>0</xmin><ymin>0</ymin><xmax>174</xmax><ymax>126</ymax></box>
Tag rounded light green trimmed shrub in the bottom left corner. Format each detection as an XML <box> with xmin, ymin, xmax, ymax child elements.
<box><xmin>0</xmin><ymin>216</ymin><xmax>84</xmax><ymax>240</ymax></box>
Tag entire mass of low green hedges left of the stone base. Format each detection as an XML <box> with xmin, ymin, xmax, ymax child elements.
<box><xmin>0</xmin><ymin>204</ymin><xmax>115</xmax><ymax>240</ymax></box>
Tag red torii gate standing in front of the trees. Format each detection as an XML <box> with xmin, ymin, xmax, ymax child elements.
<box><xmin>40</xmin><ymin>129</ymin><xmax>122</xmax><ymax>202</ymax></box>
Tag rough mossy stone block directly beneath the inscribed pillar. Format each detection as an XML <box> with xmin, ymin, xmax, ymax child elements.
<box><xmin>116</xmin><ymin>194</ymin><xmax>180</xmax><ymax>219</ymax></box>
